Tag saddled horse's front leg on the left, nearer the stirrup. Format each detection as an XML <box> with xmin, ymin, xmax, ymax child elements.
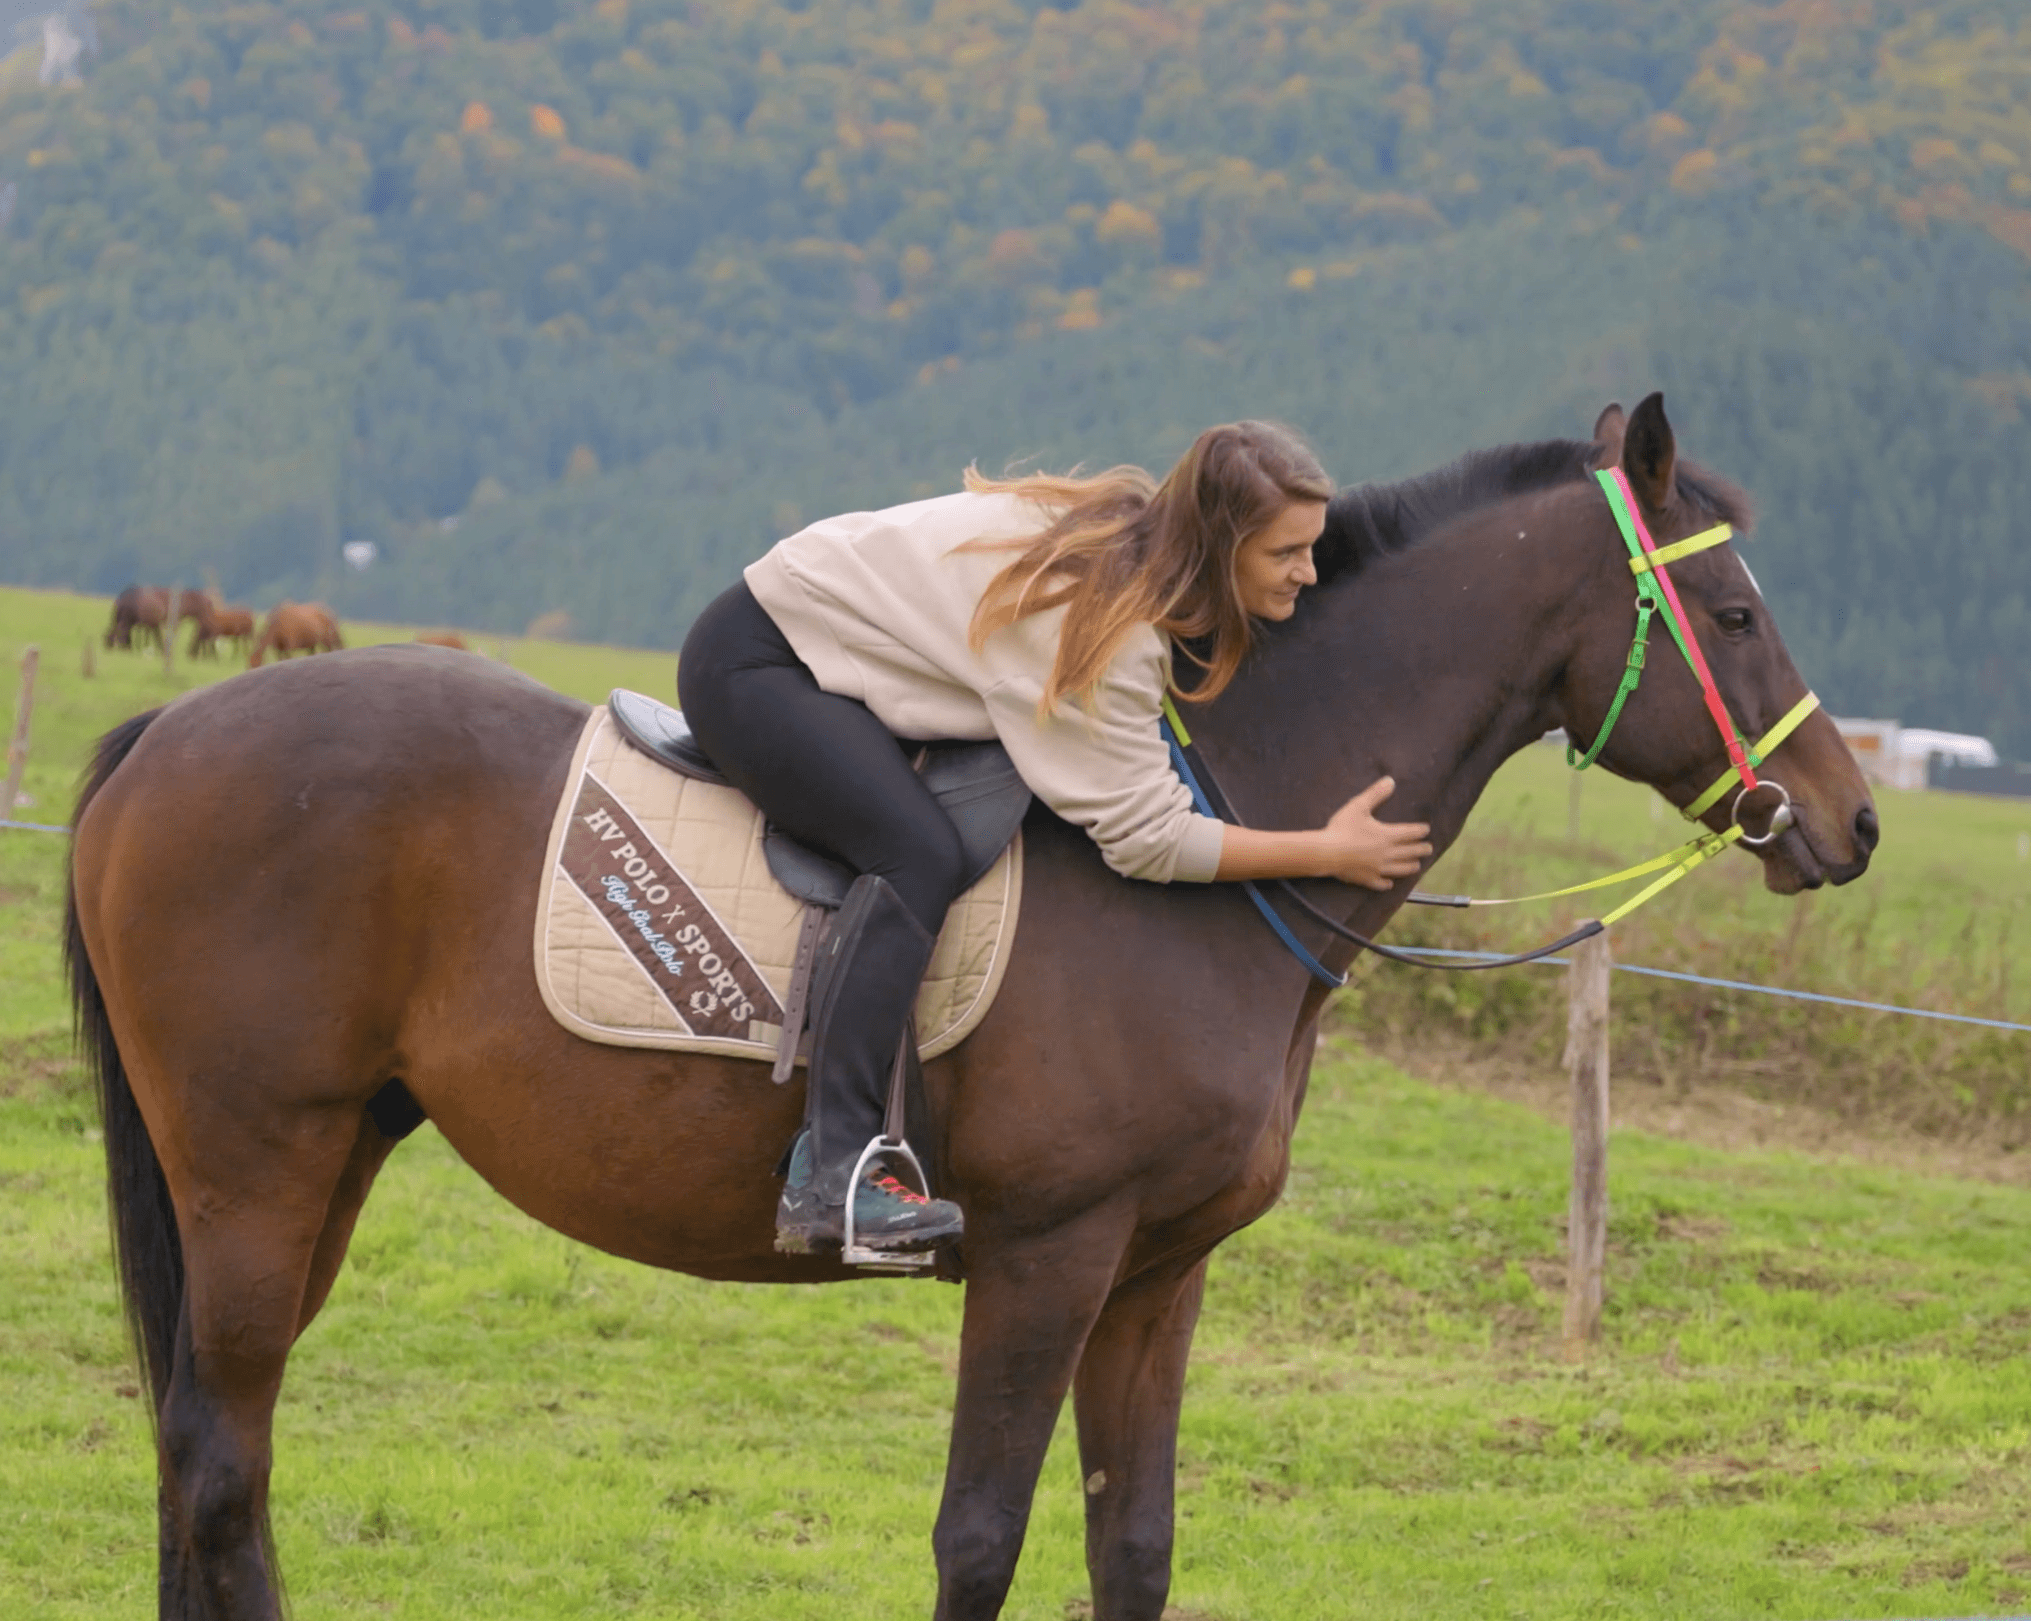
<box><xmin>932</xmin><ymin>1203</ymin><xmax>1135</xmax><ymax>1621</ymax></box>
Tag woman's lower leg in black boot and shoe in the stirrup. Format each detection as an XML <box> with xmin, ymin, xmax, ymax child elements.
<box><xmin>776</xmin><ymin>873</ymin><xmax>965</xmax><ymax>1255</ymax></box>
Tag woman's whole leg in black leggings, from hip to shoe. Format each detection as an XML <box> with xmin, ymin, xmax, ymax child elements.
<box><xmin>680</xmin><ymin>585</ymin><xmax>965</xmax><ymax>1253</ymax></box>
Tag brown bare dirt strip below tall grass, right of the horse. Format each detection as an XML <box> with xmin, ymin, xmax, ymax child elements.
<box><xmin>1347</xmin><ymin>1030</ymin><xmax>2031</xmax><ymax>1186</ymax></box>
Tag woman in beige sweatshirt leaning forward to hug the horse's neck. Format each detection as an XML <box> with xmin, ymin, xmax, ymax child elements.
<box><xmin>678</xmin><ymin>423</ymin><xmax>1432</xmax><ymax>1253</ymax></box>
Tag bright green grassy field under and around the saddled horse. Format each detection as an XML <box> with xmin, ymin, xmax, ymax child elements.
<box><xmin>0</xmin><ymin>591</ymin><xmax>2031</xmax><ymax>1621</ymax></box>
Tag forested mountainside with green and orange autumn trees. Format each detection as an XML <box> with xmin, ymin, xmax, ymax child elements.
<box><xmin>0</xmin><ymin>0</ymin><xmax>2031</xmax><ymax>756</ymax></box>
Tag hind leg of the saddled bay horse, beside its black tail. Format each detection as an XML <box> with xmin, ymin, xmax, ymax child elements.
<box><xmin>160</xmin><ymin>1109</ymin><xmax>364</xmax><ymax>1621</ymax></box>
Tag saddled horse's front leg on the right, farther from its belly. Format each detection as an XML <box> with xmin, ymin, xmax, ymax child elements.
<box><xmin>1072</xmin><ymin>1255</ymin><xmax>1206</xmax><ymax>1621</ymax></box>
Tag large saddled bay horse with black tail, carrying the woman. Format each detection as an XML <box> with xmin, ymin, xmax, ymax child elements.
<box><xmin>67</xmin><ymin>396</ymin><xmax>1877</xmax><ymax>1621</ymax></box>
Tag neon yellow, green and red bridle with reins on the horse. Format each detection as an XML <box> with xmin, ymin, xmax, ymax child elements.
<box><xmin>1164</xmin><ymin>467</ymin><xmax>1820</xmax><ymax>985</ymax></box>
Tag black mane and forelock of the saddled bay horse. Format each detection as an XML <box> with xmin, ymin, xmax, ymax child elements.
<box><xmin>1312</xmin><ymin>439</ymin><xmax>1755</xmax><ymax>585</ymax></box>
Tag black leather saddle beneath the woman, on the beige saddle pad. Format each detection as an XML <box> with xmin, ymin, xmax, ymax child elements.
<box><xmin>607</xmin><ymin>687</ymin><xmax>1030</xmax><ymax>910</ymax></box>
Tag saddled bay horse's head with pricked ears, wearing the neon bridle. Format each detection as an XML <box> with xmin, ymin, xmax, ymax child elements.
<box><xmin>1560</xmin><ymin>394</ymin><xmax>1879</xmax><ymax>894</ymax></box>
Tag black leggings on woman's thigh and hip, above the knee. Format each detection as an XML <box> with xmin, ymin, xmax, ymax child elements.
<box><xmin>678</xmin><ymin>581</ymin><xmax>967</xmax><ymax>934</ymax></box>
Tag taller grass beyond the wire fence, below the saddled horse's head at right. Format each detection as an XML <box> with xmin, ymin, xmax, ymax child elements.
<box><xmin>1338</xmin><ymin>748</ymin><xmax>2031</xmax><ymax>1148</ymax></box>
